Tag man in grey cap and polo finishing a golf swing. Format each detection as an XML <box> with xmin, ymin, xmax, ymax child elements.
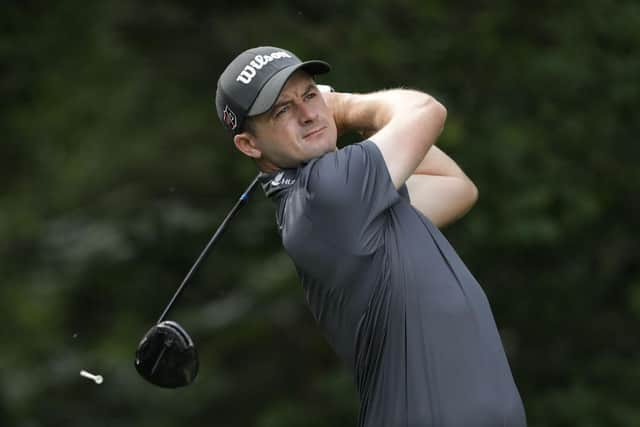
<box><xmin>216</xmin><ymin>47</ymin><xmax>526</xmax><ymax>427</ymax></box>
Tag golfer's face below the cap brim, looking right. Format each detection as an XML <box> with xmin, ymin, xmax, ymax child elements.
<box><xmin>242</xmin><ymin>70</ymin><xmax>338</xmax><ymax>171</ymax></box>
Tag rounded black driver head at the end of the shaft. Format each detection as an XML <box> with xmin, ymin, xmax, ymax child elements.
<box><xmin>135</xmin><ymin>320</ymin><xmax>198</xmax><ymax>388</ymax></box>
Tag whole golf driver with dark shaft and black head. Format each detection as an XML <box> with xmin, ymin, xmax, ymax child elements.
<box><xmin>135</xmin><ymin>175</ymin><xmax>260</xmax><ymax>388</ymax></box>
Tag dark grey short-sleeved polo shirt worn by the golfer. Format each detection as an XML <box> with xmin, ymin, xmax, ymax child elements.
<box><xmin>261</xmin><ymin>141</ymin><xmax>526</xmax><ymax>427</ymax></box>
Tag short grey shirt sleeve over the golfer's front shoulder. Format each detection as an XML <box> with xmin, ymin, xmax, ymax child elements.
<box><xmin>306</xmin><ymin>141</ymin><xmax>401</xmax><ymax>252</ymax></box>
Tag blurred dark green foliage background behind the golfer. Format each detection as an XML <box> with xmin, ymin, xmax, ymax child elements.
<box><xmin>0</xmin><ymin>0</ymin><xmax>640</xmax><ymax>427</ymax></box>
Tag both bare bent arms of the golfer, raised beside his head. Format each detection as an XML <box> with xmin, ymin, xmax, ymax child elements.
<box><xmin>325</xmin><ymin>90</ymin><xmax>478</xmax><ymax>227</ymax></box>
